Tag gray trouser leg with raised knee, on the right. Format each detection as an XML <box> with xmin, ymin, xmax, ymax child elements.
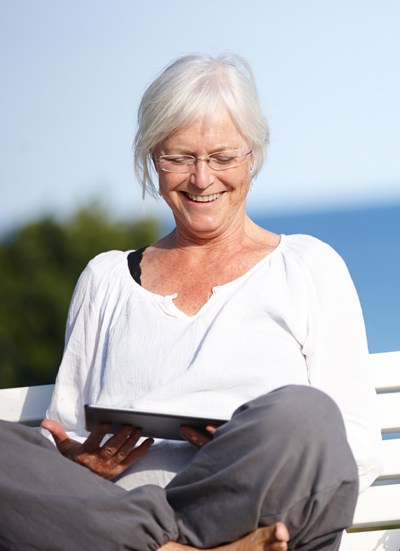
<box><xmin>167</xmin><ymin>386</ymin><xmax>358</xmax><ymax>551</ymax></box>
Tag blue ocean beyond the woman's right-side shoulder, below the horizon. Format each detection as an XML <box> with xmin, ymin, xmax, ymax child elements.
<box><xmin>253</xmin><ymin>204</ymin><xmax>400</xmax><ymax>352</ymax></box>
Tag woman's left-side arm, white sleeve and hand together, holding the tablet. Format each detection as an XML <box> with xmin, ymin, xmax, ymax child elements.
<box><xmin>42</xmin><ymin>253</ymin><xmax>153</xmax><ymax>479</ymax></box>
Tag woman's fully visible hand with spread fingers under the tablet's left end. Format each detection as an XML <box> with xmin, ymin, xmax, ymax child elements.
<box><xmin>41</xmin><ymin>419</ymin><xmax>154</xmax><ymax>480</ymax></box>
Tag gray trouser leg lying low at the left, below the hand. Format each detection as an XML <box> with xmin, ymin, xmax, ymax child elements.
<box><xmin>0</xmin><ymin>421</ymin><xmax>177</xmax><ymax>551</ymax></box>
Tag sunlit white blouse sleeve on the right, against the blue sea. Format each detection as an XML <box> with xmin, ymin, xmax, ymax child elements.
<box><xmin>303</xmin><ymin>244</ymin><xmax>381</xmax><ymax>492</ymax></box>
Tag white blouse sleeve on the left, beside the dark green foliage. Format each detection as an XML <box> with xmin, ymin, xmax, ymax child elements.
<box><xmin>44</xmin><ymin>263</ymin><xmax>100</xmax><ymax>441</ymax></box>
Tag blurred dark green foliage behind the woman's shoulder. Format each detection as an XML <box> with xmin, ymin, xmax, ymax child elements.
<box><xmin>0</xmin><ymin>205</ymin><xmax>159</xmax><ymax>388</ymax></box>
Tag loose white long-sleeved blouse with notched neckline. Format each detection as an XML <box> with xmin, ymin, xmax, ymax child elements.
<box><xmin>43</xmin><ymin>235</ymin><xmax>380</xmax><ymax>498</ymax></box>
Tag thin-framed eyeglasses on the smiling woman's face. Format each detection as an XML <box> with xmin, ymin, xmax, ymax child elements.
<box><xmin>154</xmin><ymin>146</ymin><xmax>254</xmax><ymax>172</ymax></box>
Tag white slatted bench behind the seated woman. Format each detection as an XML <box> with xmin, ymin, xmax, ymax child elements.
<box><xmin>0</xmin><ymin>352</ymin><xmax>400</xmax><ymax>551</ymax></box>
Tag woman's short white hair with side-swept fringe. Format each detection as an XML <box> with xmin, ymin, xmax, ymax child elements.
<box><xmin>134</xmin><ymin>54</ymin><xmax>269</xmax><ymax>198</ymax></box>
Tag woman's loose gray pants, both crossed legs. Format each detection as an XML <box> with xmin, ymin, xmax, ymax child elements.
<box><xmin>0</xmin><ymin>386</ymin><xmax>358</xmax><ymax>551</ymax></box>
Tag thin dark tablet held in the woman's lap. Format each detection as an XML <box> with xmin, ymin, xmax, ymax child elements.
<box><xmin>85</xmin><ymin>404</ymin><xmax>227</xmax><ymax>440</ymax></box>
